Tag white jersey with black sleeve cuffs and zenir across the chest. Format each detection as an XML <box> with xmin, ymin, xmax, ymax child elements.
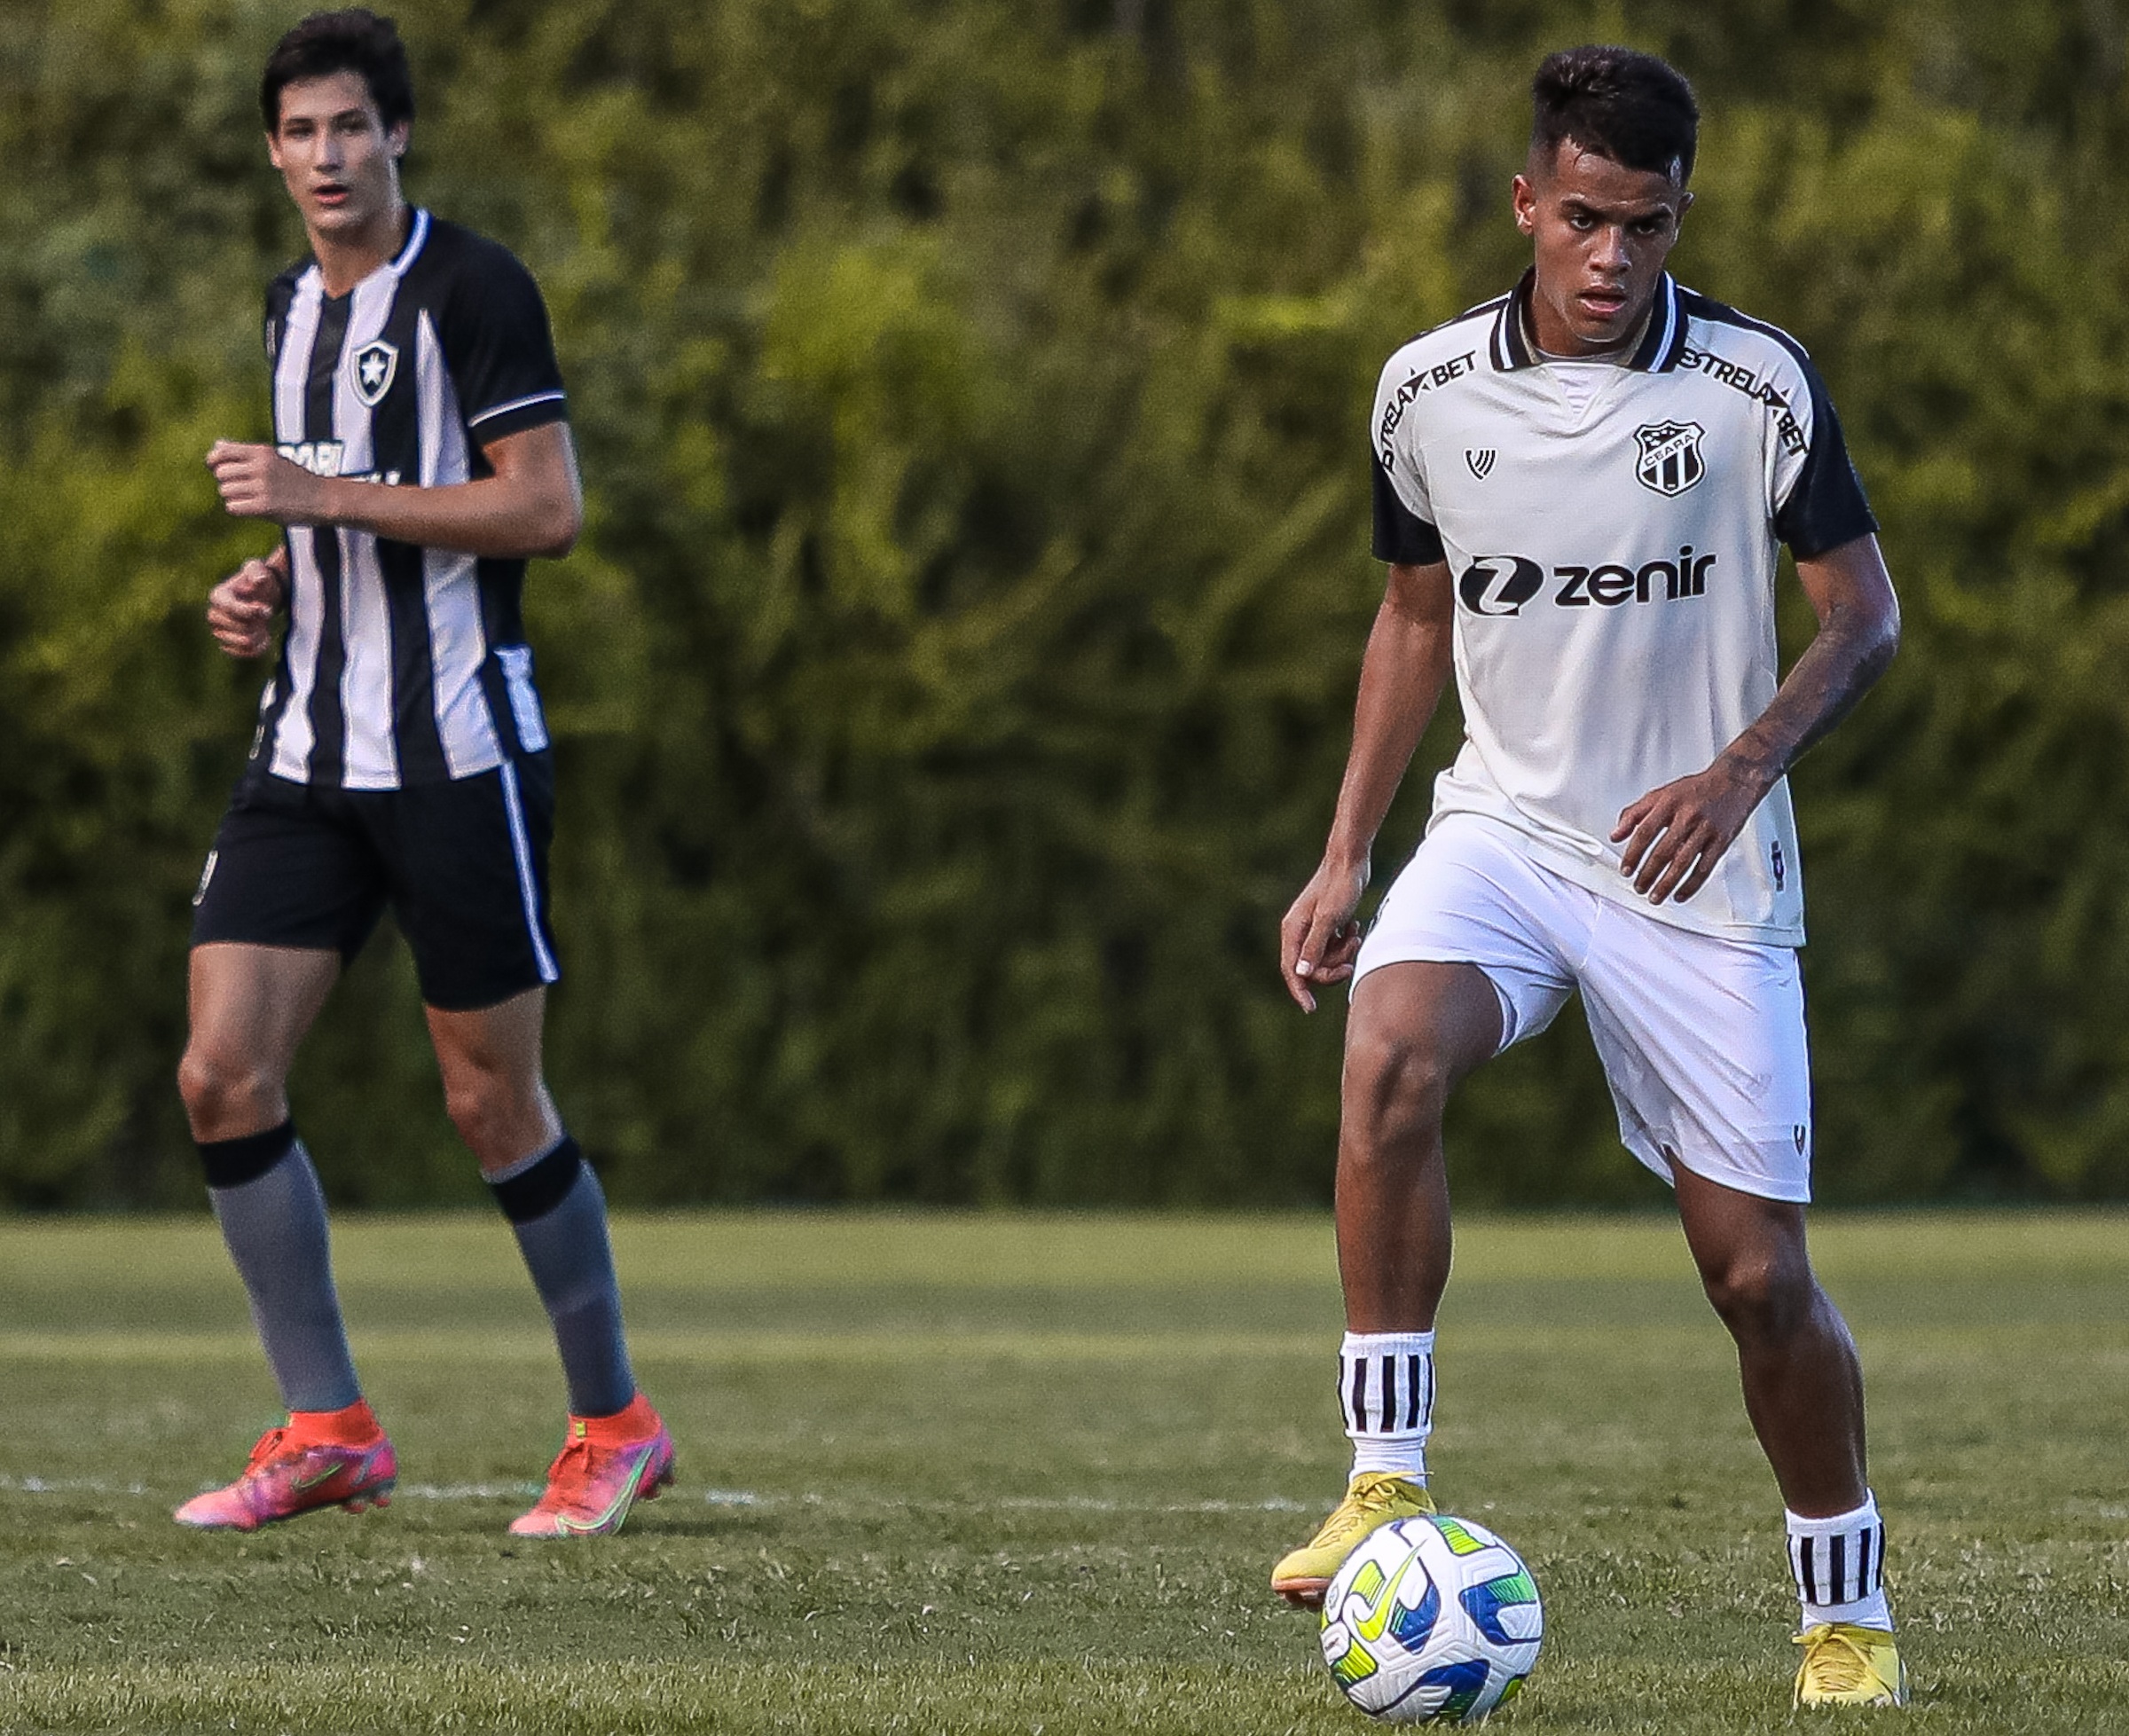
<box><xmin>1373</xmin><ymin>275</ymin><xmax>1878</xmax><ymax>946</ymax></box>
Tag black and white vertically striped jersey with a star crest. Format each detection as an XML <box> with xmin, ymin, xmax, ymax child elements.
<box><xmin>251</xmin><ymin>211</ymin><xmax>566</xmax><ymax>790</ymax></box>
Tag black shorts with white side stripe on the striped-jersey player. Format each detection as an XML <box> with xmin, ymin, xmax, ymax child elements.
<box><xmin>192</xmin><ymin>754</ymin><xmax>560</xmax><ymax>1012</ymax></box>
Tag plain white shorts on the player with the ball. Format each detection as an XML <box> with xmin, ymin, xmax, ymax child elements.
<box><xmin>1354</xmin><ymin>813</ymin><xmax>1811</xmax><ymax>1201</ymax></box>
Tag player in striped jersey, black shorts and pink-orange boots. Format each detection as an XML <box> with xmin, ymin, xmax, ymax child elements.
<box><xmin>177</xmin><ymin>11</ymin><xmax>672</xmax><ymax>1536</ymax></box>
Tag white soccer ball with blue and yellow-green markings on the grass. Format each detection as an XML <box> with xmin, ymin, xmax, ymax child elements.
<box><xmin>1322</xmin><ymin>1514</ymin><xmax>1545</xmax><ymax>1724</ymax></box>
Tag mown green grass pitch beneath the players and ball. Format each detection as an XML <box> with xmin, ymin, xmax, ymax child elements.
<box><xmin>0</xmin><ymin>1216</ymin><xmax>2129</xmax><ymax>1736</ymax></box>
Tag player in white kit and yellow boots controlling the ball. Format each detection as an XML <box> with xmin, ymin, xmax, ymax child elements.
<box><xmin>1273</xmin><ymin>47</ymin><xmax>1905</xmax><ymax>1704</ymax></box>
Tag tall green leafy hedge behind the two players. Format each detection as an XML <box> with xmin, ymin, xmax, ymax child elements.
<box><xmin>0</xmin><ymin>0</ymin><xmax>2129</xmax><ymax>1207</ymax></box>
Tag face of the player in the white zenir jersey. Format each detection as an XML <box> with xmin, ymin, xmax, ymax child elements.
<box><xmin>1516</xmin><ymin>138</ymin><xmax>1693</xmax><ymax>356</ymax></box>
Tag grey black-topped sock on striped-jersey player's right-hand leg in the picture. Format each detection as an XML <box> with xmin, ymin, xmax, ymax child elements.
<box><xmin>490</xmin><ymin>1133</ymin><xmax>637</xmax><ymax>1417</ymax></box>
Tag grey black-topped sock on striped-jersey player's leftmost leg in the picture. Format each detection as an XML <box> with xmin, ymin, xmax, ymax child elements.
<box><xmin>200</xmin><ymin>1122</ymin><xmax>362</xmax><ymax>1410</ymax></box>
